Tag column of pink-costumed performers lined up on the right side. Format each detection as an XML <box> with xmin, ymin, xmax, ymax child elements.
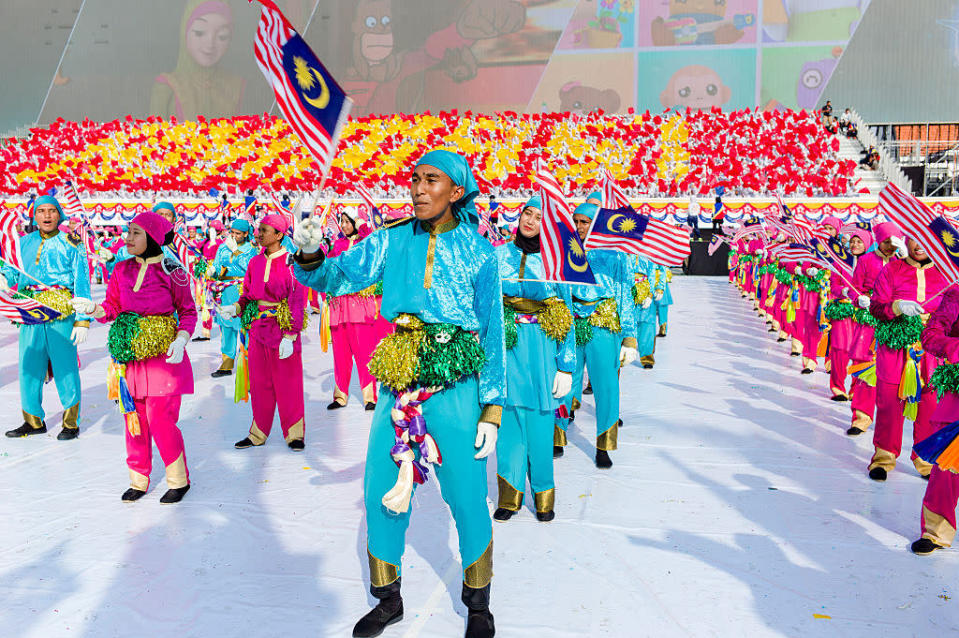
<box><xmin>729</xmin><ymin>217</ymin><xmax>959</xmax><ymax>555</ymax></box>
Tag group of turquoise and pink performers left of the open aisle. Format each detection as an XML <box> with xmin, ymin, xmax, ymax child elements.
<box><xmin>0</xmin><ymin>151</ymin><xmax>672</xmax><ymax>637</ymax></box>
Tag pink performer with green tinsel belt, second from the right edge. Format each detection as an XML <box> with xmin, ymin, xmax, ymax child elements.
<box><xmin>869</xmin><ymin>239</ymin><xmax>949</xmax><ymax>481</ymax></box>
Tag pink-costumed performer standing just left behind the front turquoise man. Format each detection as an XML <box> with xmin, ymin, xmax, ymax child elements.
<box><xmin>220</xmin><ymin>215</ymin><xmax>306</xmax><ymax>452</ymax></box>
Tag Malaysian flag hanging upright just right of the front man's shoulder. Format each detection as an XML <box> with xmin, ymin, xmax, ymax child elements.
<box><xmin>536</xmin><ymin>160</ymin><xmax>596</xmax><ymax>284</ymax></box>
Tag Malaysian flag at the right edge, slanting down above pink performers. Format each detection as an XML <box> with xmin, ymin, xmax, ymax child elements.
<box><xmin>879</xmin><ymin>183</ymin><xmax>959</xmax><ymax>283</ymax></box>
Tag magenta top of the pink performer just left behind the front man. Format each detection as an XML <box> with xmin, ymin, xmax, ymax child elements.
<box><xmin>238</xmin><ymin>249</ymin><xmax>306</xmax><ymax>352</ymax></box>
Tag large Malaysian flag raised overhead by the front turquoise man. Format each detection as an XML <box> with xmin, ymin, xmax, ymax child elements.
<box><xmin>253</xmin><ymin>0</ymin><xmax>352</xmax><ymax>177</ymax></box>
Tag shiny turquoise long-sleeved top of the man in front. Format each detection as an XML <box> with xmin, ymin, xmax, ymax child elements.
<box><xmin>294</xmin><ymin>219</ymin><xmax>506</xmax><ymax>406</ymax></box>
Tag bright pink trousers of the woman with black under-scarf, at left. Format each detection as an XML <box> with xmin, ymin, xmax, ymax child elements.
<box><xmin>126</xmin><ymin>394</ymin><xmax>190</xmax><ymax>492</ymax></box>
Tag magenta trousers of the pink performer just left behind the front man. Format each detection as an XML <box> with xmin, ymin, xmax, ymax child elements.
<box><xmin>249</xmin><ymin>339</ymin><xmax>304</xmax><ymax>445</ymax></box>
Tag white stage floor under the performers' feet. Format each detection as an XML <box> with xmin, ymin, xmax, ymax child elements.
<box><xmin>0</xmin><ymin>277</ymin><xmax>959</xmax><ymax>638</ymax></box>
